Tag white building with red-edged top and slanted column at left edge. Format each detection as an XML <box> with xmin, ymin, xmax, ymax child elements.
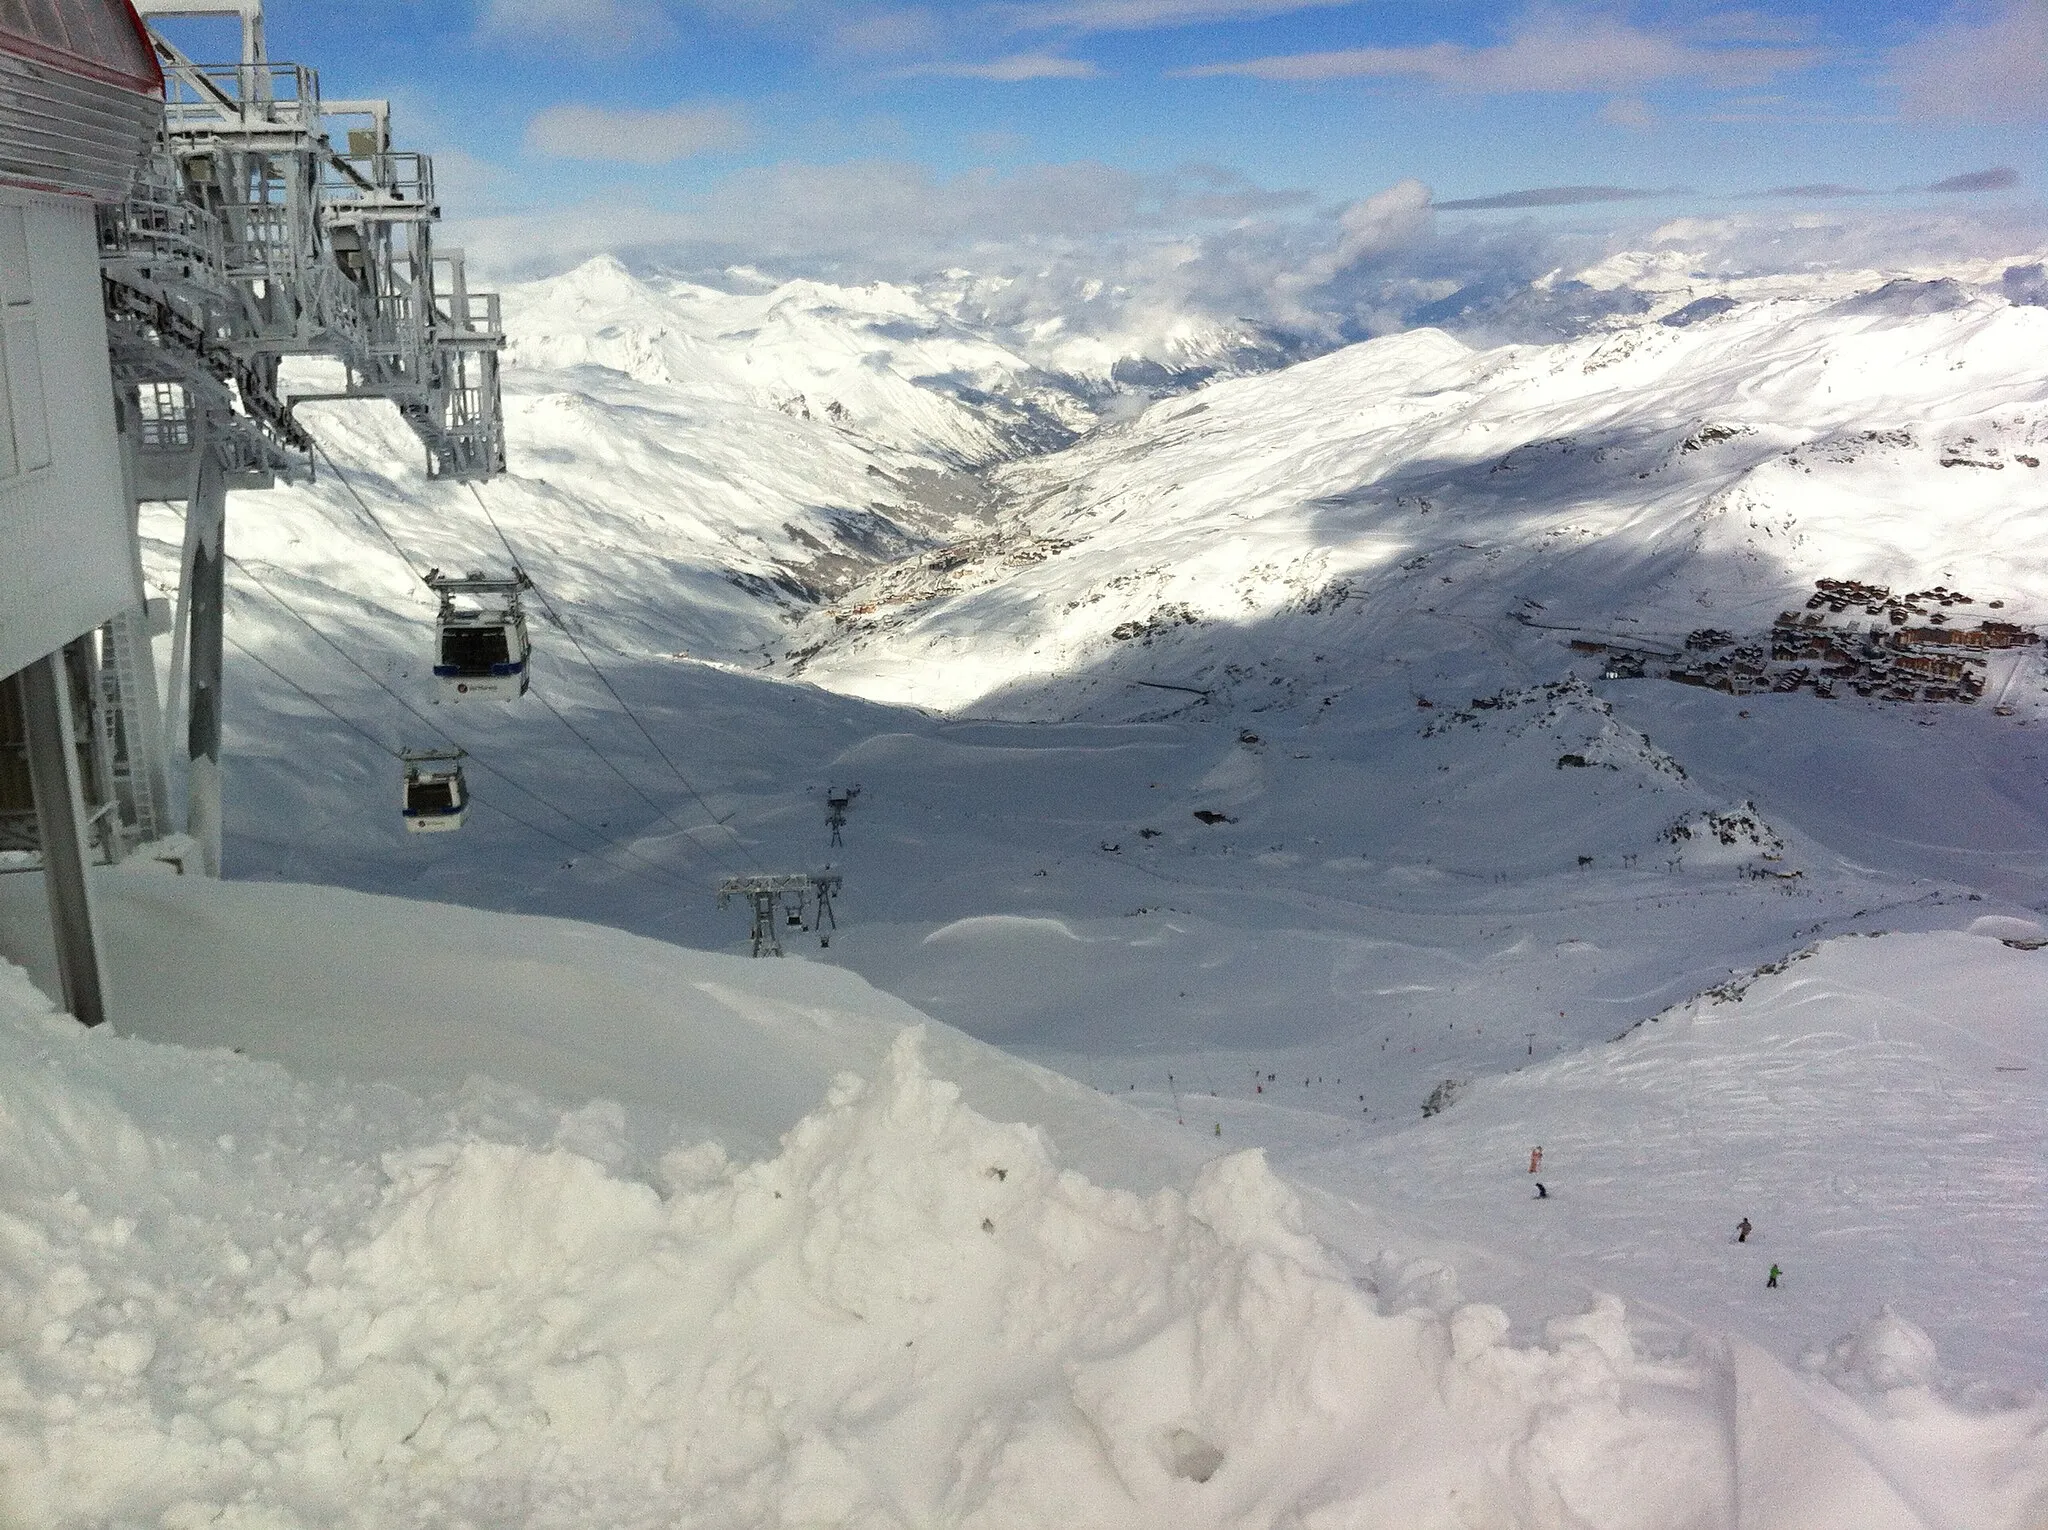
<box><xmin>0</xmin><ymin>0</ymin><xmax>164</xmax><ymax>1024</ymax></box>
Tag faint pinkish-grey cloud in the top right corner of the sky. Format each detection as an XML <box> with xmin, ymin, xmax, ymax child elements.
<box><xmin>1888</xmin><ymin>0</ymin><xmax>2048</xmax><ymax>123</ymax></box>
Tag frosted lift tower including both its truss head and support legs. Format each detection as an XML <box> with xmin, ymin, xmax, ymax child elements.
<box><xmin>98</xmin><ymin>0</ymin><xmax>506</xmax><ymax>875</ymax></box>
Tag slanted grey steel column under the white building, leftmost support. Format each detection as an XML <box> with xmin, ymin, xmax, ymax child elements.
<box><xmin>16</xmin><ymin>651</ymin><xmax>106</xmax><ymax>1026</ymax></box>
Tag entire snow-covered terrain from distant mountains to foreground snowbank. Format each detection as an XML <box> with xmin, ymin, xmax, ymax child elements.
<box><xmin>0</xmin><ymin>245</ymin><xmax>2048</xmax><ymax>1530</ymax></box>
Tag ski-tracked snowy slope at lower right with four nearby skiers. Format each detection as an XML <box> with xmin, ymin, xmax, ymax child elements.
<box><xmin>1288</xmin><ymin>922</ymin><xmax>2048</xmax><ymax>1378</ymax></box>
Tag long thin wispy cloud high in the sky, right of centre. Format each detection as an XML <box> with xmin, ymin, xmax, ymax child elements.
<box><xmin>1180</xmin><ymin>10</ymin><xmax>1819</xmax><ymax>94</ymax></box>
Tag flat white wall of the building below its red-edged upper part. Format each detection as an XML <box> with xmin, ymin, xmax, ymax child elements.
<box><xmin>0</xmin><ymin>184</ymin><xmax>141</xmax><ymax>676</ymax></box>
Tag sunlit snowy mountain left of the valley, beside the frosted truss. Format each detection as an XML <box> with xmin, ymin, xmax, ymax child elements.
<box><xmin>460</xmin><ymin>258</ymin><xmax>1294</xmax><ymax>618</ymax></box>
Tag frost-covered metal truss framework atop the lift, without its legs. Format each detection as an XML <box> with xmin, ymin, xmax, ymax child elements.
<box><xmin>100</xmin><ymin>0</ymin><xmax>504</xmax><ymax>479</ymax></box>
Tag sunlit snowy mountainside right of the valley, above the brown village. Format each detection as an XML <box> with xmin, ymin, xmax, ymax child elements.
<box><xmin>791</xmin><ymin>285</ymin><xmax>2048</xmax><ymax>717</ymax></box>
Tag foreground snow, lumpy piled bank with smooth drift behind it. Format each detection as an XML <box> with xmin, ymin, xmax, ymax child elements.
<box><xmin>0</xmin><ymin>873</ymin><xmax>2048</xmax><ymax>1530</ymax></box>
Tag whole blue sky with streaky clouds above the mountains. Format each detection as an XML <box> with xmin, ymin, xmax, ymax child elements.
<box><xmin>155</xmin><ymin>0</ymin><xmax>2048</xmax><ymax>274</ymax></box>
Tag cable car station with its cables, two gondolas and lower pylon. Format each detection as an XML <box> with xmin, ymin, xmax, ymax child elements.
<box><xmin>0</xmin><ymin>0</ymin><xmax>858</xmax><ymax>1003</ymax></box>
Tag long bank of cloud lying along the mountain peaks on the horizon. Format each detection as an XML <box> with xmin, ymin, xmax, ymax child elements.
<box><xmin>449</xmin><ymin>162</ymin><xmax>2048</xmax><ymax>356</ymax></box>
